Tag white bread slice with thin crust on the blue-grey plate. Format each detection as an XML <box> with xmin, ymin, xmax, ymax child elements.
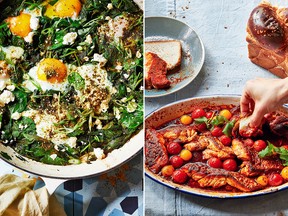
<box><xmin>145</xmin><ymin>40</ymin><xmax>182</xmax><ymax>70</ymax></box>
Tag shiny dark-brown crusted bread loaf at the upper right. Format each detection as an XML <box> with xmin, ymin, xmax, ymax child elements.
<box><xmin>246</xmin><ymin>2</ymin><xmax>288</xmax><ymax>78</ymax></box>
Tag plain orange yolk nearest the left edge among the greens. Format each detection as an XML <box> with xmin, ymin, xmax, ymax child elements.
<box><xmin>6</xmin><ymin>13</ymin><xmax>31</xmax><ymax>38</ymax></box>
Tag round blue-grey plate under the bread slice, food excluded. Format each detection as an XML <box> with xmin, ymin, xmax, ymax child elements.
<box><xmin>145</xmin><ymin>17</ymin><xmax>205</xmax><ymax>97</ymax></box>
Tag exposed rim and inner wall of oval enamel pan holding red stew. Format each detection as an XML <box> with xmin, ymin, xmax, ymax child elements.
<box><xmin>145</xmin><ymin>95</ymin><xmax>288</xmax><ymax>198</ymax></box>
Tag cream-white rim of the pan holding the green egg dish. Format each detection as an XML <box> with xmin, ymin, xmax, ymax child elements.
<box><xmin>0</xmin><ymin>130</ymin><xmax>144</xmax><ymax>179</ymax></box>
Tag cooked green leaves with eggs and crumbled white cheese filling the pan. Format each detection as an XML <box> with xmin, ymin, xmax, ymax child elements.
<box><xmin>0</xmin><ymin>0</ymin><xmax>143</xmax><ymax>165</ymax></box>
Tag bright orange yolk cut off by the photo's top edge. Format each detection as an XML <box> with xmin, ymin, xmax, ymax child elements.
<box><xmin>44</xmin><ymin>0</ymin><xmax>82</xmax><ymax>18</ymax></box>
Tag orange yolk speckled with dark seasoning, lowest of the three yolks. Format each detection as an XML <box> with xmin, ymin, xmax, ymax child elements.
<box><xmin>37</xmin><ymin>58</ymin><xmax>67</xmax><ymax>83</ymax></box>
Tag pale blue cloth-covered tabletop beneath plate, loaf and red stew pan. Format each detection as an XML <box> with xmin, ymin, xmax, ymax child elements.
<box><xmin>145</xmin><ymin>0</ymin><xmax>288</xmax><ymax>216</ymax></box>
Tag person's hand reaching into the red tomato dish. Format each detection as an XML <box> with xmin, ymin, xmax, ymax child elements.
<box><xmin>240</xmin><ymin>78</ymin><xmax>288</xmax><ymax>127</ymax></box>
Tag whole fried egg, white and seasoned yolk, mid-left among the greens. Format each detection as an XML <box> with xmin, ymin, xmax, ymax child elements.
<box><xmin>24</xmin><ymin>58</ymin><xmax>68</xmax><ymax>91</ymax></box>
